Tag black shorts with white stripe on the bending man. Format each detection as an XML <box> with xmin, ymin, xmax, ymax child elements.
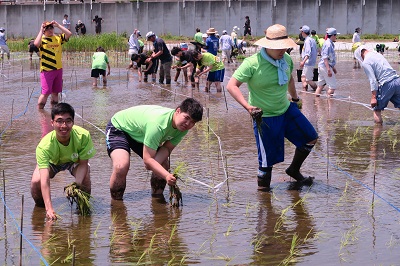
<box><xmin>106</xmin><ymin>121</ymin><xmax>143</xmax><ymax>159</ymax></box>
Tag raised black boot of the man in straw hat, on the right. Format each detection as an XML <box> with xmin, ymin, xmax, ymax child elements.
<box><xmin>285</xmin><ymin>145</ymin><xmax>314</xmax><ymax>186</ymax></box>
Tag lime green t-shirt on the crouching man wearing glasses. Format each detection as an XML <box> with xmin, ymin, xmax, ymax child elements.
<box><xmin>36</xmin><ymin>125</ymin><xmax>96</xmax><ymax>169</ymax></box>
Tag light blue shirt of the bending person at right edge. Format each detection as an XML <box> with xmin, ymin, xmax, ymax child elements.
<box><xmin>362</xmin><ymin>51</ymin><xmax>399</xmax><ymax>91</ymax></box>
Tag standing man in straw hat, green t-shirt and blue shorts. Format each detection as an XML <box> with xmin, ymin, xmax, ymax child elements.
<box><xmin>227</xmin><ymin>24</ymin><xmax>318</xmax><ymax>191</ymax></box>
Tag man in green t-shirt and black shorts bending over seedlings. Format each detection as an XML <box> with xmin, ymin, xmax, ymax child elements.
<box><xmin>106</xmin><ymin>98</ymin><xmax>203</xmax><ymax>200</ymax></box>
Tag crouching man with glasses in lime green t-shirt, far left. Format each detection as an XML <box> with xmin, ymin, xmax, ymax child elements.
<box><xmin>31</xmin><ymin>103</ymin><xmax>96</xmax><ymax>220</ymax></box>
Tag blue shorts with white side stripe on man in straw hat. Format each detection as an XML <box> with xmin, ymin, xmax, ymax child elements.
<box><xmin>253</xmin><ymin>103</ymin><xmax>318</xmax><ymax>167</ymax></box>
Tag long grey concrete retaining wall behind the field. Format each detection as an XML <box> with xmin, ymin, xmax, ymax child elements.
<box><xmin>0</xmin><ymin>0</ymin><xmax>400</xmax><ymax>38</ymax></box>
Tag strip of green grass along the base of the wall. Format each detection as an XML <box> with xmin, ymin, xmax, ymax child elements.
<box><xmin>7</xmin><ymin>32</ymin><xmax>398</xmax><ymax>52</ymax></box>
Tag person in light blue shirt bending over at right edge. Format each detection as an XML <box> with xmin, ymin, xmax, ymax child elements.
<box><xmin>354</xmin><ymin>45</ymin><xmax>400</xmax><ymax>124</ymax></box>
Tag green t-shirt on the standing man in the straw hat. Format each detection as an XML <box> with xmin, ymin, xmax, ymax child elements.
<box><xmin>233</xmin><ymin>53</ymin><xmax>293</xmax><ymax>117</ymax></box>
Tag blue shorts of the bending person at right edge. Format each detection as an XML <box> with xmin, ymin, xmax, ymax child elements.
<box><xmin>374</xmin><ymin>78</ymin><xmax>400</xmax><ymax>110</ymax></box>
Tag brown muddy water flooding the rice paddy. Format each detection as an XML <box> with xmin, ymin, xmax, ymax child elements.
<box><xmin>0</xmin><ymin>50</ymin><xmax>400</xmax><ymax>265</ymax></box>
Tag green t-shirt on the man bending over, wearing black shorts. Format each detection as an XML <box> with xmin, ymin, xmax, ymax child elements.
<box><xmin>111</xmin><ymin>105</ymin><xmax>188</xmax><ymax>150</ymax></box>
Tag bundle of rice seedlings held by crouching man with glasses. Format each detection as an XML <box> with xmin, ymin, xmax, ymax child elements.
<box><xmin>64</xmin><ymin>182</ymin><xmax>93</xmax><ymax>216</ymax></box>
